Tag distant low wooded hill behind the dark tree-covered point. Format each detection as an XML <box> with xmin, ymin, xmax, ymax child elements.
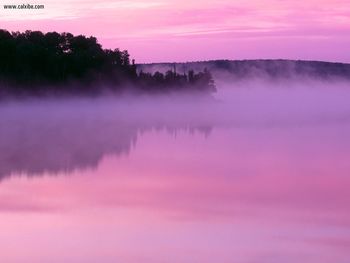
<box><xmin>137</xmin><ymin>59</ymin><xmax>350</xmax><ymax>80</ymax></box>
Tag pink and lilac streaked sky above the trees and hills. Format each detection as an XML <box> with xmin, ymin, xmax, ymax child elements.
<box><xmin>0</xmin><ymin>0</ymin><xmax>350</xmax><ymax>62</ymax></box>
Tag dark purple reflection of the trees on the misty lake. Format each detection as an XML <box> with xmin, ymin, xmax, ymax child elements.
<box><xmin>0</xmin><ymin>97</ymin><xmax>212</xmax><ymax>182</ymax></box>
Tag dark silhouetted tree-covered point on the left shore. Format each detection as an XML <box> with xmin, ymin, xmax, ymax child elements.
<box><xmin>0</xmin><ymin>30</ymin><xmax>215</xmax><ymax>93</ymax></box>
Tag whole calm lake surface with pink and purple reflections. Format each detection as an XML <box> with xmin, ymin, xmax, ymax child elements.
<box><xmin>0</xmin><ymin>81</ymin><xmax>350</xmax><ymax>263</ymax></box>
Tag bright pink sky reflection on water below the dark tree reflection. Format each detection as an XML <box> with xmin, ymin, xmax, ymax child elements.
<box><xmin>0</xmin><ymin>124</ymin><xmax>350</xmax><ymax>263</ymax></box>
